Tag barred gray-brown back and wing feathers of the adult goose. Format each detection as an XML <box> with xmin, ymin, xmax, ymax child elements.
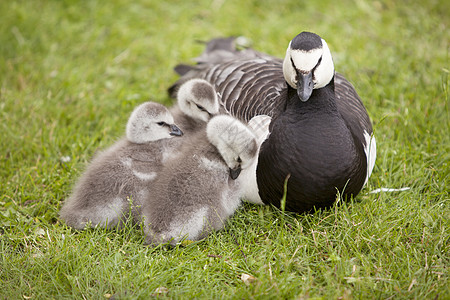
<box><xmin>169</xmin><ymin>38</ymin><xmax>372</xmax><ymax>134</ymax></box>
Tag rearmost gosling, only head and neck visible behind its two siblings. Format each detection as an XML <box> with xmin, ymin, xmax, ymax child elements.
<box><xmin>170</xmin><ymin>79</ymin><xmax>219</xmax><ymax>138</ymax></box>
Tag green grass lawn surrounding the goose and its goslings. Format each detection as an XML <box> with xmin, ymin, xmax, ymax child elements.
<box><xmin>0</xmin><ymin>0</ymin><xmax>450</xmax><ymax>299</ymax></box>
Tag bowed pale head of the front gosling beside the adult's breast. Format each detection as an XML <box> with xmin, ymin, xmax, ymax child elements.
<box><xmin>206</xmin><ymin>115</ymin><xmax>258</xmax><ymax>180</ymax></box>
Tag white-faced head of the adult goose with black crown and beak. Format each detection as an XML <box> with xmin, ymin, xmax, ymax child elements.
<box><xmin>283</xmin><ymin>31</ymin><xmax>334</xmax><ymax>102</ymax></box>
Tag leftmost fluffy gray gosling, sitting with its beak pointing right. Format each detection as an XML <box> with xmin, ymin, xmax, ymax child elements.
<box><xmin>60</xmin><ymin>102</ymin><xmax>183</xmax><ymax>229</ymax></box>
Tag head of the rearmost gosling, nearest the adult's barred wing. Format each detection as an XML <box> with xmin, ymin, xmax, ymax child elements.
<box><xmin>177</xmin><ymin>78</ymin><xmax>219</xmax><ymax>122</ymax></box>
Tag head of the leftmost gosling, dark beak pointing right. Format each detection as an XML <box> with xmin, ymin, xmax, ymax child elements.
<box><xmin>126</xmin><ymin>102</ymin><xmax>183</xmax><ymax>144</ymax></box>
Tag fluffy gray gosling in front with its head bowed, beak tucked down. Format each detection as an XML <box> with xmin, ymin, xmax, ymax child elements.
<box><xmin>142</xmin><ymin>115</ymin><xmax>258</xmax><ymax>246</ymax></box>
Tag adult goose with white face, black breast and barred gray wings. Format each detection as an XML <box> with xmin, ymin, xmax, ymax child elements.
<box><xmin>169</xmin><ymin>32</ymin><xmax>376</xmax><ymax>212</ymax></box>
